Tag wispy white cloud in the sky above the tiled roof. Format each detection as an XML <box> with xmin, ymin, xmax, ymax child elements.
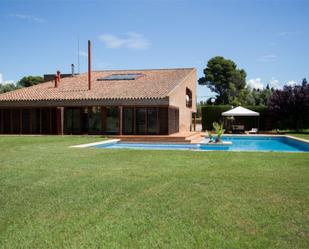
<box><xmin>99</xmin><ymin>32</ymin><xmax>151</xmax><ymax>50</ymax></box>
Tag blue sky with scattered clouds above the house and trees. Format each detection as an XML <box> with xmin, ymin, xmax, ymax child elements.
<box><xmin>0</xmin><ymin>0</ymin><xmax>309</xmax><ymax>100</ymax></box>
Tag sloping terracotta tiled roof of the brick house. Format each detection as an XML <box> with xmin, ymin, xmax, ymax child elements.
<box><xmin>0</xmin><ymin>68</ymin><xmax>195</xmax><ymax>102</ymax></box>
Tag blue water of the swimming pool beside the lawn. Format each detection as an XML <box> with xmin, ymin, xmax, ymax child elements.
<box><xmin>94</xmin><ymin>135</ymin><xmax>309</xmax><ymax>152</ymax></box>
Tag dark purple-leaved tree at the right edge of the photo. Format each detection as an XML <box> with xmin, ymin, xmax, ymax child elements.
<box><xmin>268</xmin><ymin>81</ymin><xmax>309</xmax><ymax>129</ymax></box>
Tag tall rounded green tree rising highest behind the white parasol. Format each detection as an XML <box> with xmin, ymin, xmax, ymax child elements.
<box><xmin>198</xmin><ymin>56</ymin><xmax>246</xmax><ymax>104</ymax></box>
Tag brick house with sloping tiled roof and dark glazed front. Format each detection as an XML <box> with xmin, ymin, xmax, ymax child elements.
<box><xmin>0</xmin><ymin>68</ymin><xmax>196</xmax><ymax>135</ymax></box>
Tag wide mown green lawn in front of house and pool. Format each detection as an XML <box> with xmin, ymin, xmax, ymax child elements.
<box><xmin>0</xmin><ymin>136</ymin><xmax>309</xmax><ymax>249</ymax></box>
